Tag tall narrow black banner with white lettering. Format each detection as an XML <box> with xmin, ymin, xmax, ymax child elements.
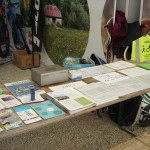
<box><xmin>31</xmin><ymin>0</ymin><xmax>43</xmax><ymax>52</ymax></box>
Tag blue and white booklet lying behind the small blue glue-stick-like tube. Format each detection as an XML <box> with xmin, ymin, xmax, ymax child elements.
<box><xmin>4</xmin><ymin>80</ymin><xmax>42</xmax><ymax>97</ymax></box>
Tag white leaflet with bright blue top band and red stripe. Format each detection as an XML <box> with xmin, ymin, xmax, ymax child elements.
<box><xmin>14</xmin><ymin>106</ymin><xmax>42</xmax><ymax>124</ymax></box>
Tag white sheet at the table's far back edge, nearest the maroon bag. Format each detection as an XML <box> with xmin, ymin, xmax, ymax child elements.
<box><xmin>105</xmin><ymin>61</ymin><xmax>135</xmax><ymax>70</ymax></box>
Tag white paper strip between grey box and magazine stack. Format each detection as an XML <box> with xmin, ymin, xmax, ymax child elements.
<box><xmin>49</xmin><ymin>81</ymin><xmax>86</xmax><ymax>91</ymax></box>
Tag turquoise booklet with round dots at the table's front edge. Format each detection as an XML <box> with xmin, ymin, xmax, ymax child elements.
<box><xmin>30</xmin><ymin>100</ymin><xmax>65</xmax><ymax>119</ymax></box>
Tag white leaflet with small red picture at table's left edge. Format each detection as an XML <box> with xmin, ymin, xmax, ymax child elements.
<box><xmin>0</xmin><ymin>94</ymin><xmax>22</xmax><ymax>108</ymax></box>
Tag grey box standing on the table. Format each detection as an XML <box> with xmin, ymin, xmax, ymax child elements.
<box><xmin>31</xmin><ymin>65</ymin><xmax>69</xmax><ymax>86</ymax></box>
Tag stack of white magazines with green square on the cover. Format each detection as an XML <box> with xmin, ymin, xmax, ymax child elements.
<box><xmin>46</xmin><ymin>87</ymin><xmax>95</xmax><ymax>114</ymax></box>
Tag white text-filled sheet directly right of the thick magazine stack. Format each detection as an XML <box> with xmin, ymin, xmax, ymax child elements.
<box><xmin>78</xmin><ymin>82</ymin><xmax>118</xmax><ymax>105</ymax></box>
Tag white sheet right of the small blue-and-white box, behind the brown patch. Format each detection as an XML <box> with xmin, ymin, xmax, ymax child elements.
<box><xmin>78</xmin><ymin>65</ymin><xmax>114</xmax><ymax>79</ymax></box>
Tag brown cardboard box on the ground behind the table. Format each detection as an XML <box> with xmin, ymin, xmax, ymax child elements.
<box><xmin>12</xmin><ymin>50</ymin><xmax>40</xmax><ymax>69</ymax></box>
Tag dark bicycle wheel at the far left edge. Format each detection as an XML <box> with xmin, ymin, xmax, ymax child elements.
<box><xmin>0</xmin><ymin>21</ymin><xmax>9</xmax><ymax>58</ymax></box>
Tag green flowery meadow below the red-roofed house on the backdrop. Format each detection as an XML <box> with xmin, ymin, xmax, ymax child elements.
<box><xmin>44</xmin><ymin>26</ymin><xmax>89</xmax><ymax>65</ymax></box>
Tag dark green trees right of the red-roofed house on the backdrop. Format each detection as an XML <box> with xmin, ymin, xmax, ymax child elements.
<box><xmin>45</xmin><ymin>0</ymin><xmax>89</xmax><ymax>30</ymax></box>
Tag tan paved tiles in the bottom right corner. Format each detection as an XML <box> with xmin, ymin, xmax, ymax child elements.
<box><xmin>110</xmin><ymin>131</ymin><xmax>150</xmax><ymax>150</ymax></box>
